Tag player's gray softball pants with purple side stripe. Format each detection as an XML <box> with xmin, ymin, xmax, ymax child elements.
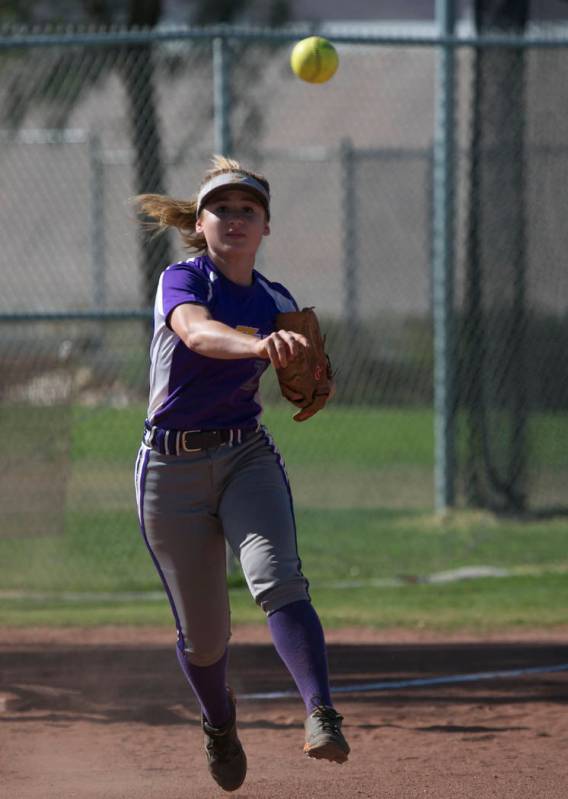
<box><xmin>135</xmin><ymin>428</ymin><xmax>309</xmax><ymax>666</ymax></box>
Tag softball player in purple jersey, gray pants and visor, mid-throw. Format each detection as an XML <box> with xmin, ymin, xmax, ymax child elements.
<box><xmin>135</xmin><ymin>156</ymin><xmax>349</xmax><ymax>791</ymax></box>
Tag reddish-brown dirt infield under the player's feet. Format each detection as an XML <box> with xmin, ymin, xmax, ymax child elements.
<box><xmin>0</xmin><ymin>628</ymin><xmax>568</xmax><ymax>799</ymax></box>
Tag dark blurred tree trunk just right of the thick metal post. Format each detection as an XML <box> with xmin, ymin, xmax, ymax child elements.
<box><xmin>461</xmin><ymin>0</ymin><xmax>529</xmax><ymax>512</ymax></box>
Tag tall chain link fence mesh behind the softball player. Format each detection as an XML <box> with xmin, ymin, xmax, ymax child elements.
<box><xmin>0</xmin><ymin>26</ymin><xmax>568</xmax><ymax>590</ymax></box>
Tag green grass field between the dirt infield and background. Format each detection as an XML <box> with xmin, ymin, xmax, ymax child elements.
<box><xmin>0</xmin><ymin>406</ymin><xmax>568</xmax><ymax>630</ymax></box>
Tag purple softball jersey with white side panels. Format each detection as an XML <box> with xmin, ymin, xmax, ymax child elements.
<box><xmin>148</xmin><ymin>255</ymin><xmax>298</xmax><ymax>430</ymax></box>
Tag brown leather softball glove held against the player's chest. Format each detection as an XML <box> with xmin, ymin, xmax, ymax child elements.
<box><xmin>275</xmin><ymin>308</ymin><xmax>333</xmax><ymax>422</ymax></box>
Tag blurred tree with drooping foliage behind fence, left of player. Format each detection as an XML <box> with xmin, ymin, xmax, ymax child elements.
<box><xmin>0</xmin><ymin>0</ymin><xmax>290</xmax><ymax>305</ymax></box>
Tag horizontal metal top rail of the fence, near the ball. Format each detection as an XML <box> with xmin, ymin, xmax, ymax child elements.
<box><xmin>0</xmin><ymin>24</ymin><xmax>568</xmax><ymax>51</ymax></box>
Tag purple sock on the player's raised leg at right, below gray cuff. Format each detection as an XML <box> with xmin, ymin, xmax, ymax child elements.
<box><xmin>268</xmin><ymin>599</ymin><xmax>332</xmax><ymax>713</ymax></box>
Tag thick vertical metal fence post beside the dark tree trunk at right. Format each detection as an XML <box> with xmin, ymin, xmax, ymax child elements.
<box><xmin>432</xmin><ymin>0</ymin><xmax>455</xmax><ymax>512</ymax></box>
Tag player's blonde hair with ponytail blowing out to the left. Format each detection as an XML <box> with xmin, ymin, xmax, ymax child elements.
<box><xmin>132</xmin><ymin>155</ymin><xmax>270</xmax><ymax>253</ymax></box>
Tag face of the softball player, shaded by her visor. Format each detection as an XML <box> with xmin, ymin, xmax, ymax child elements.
<box><xmin>195</xmin><ymin>189</ymin><xmax>270</xmax><ymax>257</ymax></box>
